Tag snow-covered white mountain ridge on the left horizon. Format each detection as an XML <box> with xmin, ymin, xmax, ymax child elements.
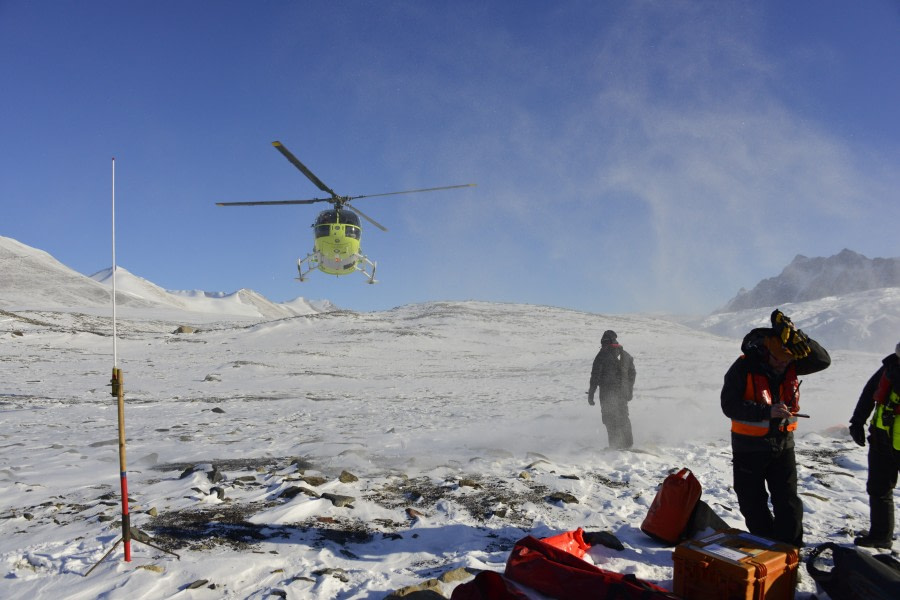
<box><xmin>0</xmin><ymin>236</ymin><xmax>333</xmax><ymax>319</ymax></box>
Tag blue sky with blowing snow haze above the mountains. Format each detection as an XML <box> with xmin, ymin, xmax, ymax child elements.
<box><xmin>0</xmin><ymin>0</ymin><xmax>900</xmax><ymax>314</ymax></box>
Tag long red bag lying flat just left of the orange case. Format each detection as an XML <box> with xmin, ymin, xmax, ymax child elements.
<box><xmin>502</xmin><ymin>536</ymin><xmax>678</xmax><ymax>600</ymax></box>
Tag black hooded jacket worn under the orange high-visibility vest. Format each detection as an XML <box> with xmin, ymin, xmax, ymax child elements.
<box><xmin>721</xmin><ymin>327</ymin><xmax>831</xmax><ymax>451</ymax></box>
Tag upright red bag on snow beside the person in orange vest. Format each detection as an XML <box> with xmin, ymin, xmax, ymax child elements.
<box><xmin>641</xmin><ymin>468</ymin><xmax>702</xmax><ymax>545</ymax></box>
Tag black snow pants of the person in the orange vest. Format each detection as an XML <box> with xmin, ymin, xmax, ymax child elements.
<box><xmin>733</xmin><ymin>444</ymin><xmax>803</xmax><ymax>548</ymax></box>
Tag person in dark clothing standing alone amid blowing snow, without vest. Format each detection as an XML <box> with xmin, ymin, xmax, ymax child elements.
<box><xmin>588</xmin><ymin>329</ymin><xmax>637</xmax><ymax>448</ymax></box>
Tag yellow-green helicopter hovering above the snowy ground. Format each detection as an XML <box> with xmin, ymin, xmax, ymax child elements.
<box><xmin>216</xmin><ymin>141</ymin><xmax>476</xmax><ymax>283</ymax></box>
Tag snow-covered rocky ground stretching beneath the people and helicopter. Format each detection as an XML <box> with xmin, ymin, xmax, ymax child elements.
<box><xmin>0</xmin><ymin>288</ymin><xmax>897</xmax><ymax>600</ymax></box>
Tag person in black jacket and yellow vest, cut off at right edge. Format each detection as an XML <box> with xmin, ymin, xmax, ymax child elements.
<box><xmin>850</xmin><ymin>344</ymin><xmax>900</xmax><ymax>548</ymax></box>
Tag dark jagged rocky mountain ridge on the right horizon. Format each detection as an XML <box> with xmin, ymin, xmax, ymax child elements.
<box><xmin>716</xmin><ymin>249</ymin><xmax>900</xmax><ymax>313</ymax></box>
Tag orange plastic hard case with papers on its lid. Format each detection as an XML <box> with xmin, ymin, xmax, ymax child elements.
<box><xmin>672</xmin><ymin>529</ymin><xmax>799</xmax><ymax>600</ymax></box>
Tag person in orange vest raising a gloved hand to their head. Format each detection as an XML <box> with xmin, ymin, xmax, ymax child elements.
<box><xmin>721</xmin><ymin>309</ymin><xmax>831</xmax><ymax>547</ymax></box>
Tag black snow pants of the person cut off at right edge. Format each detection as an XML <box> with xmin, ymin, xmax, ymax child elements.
<box><xmin>866</xmin><ymin>428</ymin><xmax>900</xmax><ymax>540</ymax></box>
